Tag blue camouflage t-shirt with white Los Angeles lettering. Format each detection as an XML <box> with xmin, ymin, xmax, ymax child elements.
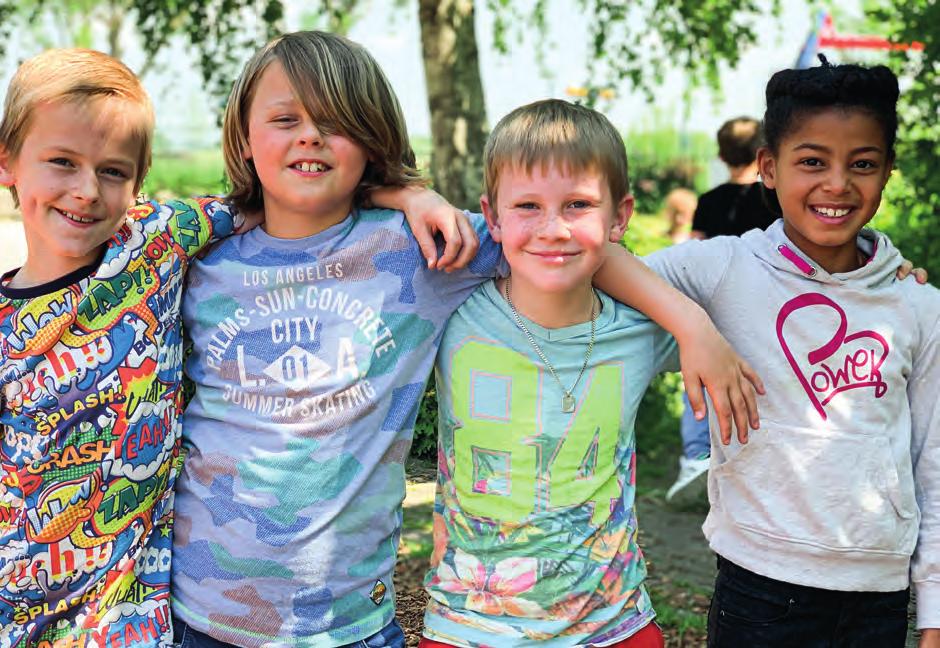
<box><xmin>173</xmin><ymin>210</ymin><xmax>501</xmax><ymax>646</ymax></box>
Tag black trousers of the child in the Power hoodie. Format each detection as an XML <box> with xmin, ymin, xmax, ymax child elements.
<box><xmin>708</xmin><ymin>557</ymin><xmax>910</xmax><ymax>648</ymax></box>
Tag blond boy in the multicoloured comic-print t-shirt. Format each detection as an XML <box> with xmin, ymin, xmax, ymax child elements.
<box><xmin>0</xmin><ymin>49</ymin><xmax>246</xmax><ymax>648</ymax></box>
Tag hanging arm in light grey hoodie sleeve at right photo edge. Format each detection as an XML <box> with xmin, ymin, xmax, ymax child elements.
<box><xmin>907</xmin><ymin>286</ymin><xmax>940</xmax><ymax>632</ymax></box>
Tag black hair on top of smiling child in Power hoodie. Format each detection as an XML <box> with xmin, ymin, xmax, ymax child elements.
<box><xmin>764</xmin><ymin>54</ymin><xmax>899</xmax><ymax>160</ymax></box>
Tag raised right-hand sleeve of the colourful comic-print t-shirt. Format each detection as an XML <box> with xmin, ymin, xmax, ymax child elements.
<box><xmin>127</xmin><ymin>196</ymin><xmax>243</xmax><ymax>261</ymax></box>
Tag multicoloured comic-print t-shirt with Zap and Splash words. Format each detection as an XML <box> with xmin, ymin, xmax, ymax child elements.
<box><xmin>0</xmin><ymin>199</ymin><xmax>242</xmax><ymax>648</ymax></box>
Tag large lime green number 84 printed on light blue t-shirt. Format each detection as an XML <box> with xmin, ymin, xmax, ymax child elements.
<box><xmin>451</xmin><ymin>341</ymin><xmax>623</xmax><ymax>526</ymax></box>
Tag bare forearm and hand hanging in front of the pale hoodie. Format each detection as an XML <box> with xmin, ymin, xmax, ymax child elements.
<box><xmin>594</xmin><ymin>241</ymin><xmax>764</xmax><ymax>444</ymax></box>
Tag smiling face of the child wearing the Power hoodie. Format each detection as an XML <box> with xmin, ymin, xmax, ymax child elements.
<box><xmin>758</xmin><ymin>109</ymin><xmax>892</xmax><ymax>272</ymax></box>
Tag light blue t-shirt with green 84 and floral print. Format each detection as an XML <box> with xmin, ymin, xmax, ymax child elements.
<box><xmin>424</xmin><ymin>282</ymin><xmax>678</xmax><ymax>646</ymax></box>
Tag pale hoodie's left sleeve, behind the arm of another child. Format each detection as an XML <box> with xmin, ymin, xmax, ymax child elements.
<box><xmin>641</xmin><ymin>236</ymin><xmax>740</xmax><ymax>307</ymax></box>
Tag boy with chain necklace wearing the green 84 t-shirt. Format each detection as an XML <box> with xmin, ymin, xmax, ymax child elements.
<box><xmin>422</xmin><ymin>100</ymin><xmax>677</xmax><ymax>648</ymax></box>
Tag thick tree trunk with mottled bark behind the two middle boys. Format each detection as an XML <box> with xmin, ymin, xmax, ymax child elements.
<box><xmin>418</xmin><ymin>0</ymin><xmax>487</xmax><ymax>211</ymax></box>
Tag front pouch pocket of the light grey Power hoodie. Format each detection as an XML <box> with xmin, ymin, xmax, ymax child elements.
<box><xmin>714</xmin><ymin>427</ymin><xmax>919</xmax><ymax>555</ymax></box>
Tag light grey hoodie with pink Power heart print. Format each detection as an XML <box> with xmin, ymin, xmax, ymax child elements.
<box><xmin>646</xmin><ymin>220</ymin><xmax>940</xmax><ymax>628</ymax></box>
